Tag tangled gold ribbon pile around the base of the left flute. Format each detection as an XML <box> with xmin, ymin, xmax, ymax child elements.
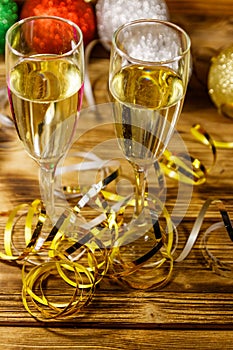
<box><xmin>0</xmin><ymin>169</ymin><xmax>122</xmax><ymax>321</ymax></box>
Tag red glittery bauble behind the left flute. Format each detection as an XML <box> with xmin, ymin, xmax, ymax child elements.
<box><xmin>20</xmin><ymin>0</ymin><xmax>96</xmax><ymax>45</ymax></box>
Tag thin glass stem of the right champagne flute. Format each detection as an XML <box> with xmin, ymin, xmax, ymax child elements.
<box><xmin>134</xmin><ymin>165</ymin><xmax>147</xmax><ymax>223</ymax></box>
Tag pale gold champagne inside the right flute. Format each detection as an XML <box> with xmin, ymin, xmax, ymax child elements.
<box><xmin>110</xmin><ymin>65</ymin><xmax>185</xmax><ymax>167</ymax></box>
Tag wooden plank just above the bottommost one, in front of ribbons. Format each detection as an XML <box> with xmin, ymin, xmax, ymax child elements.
<box><xmin>0</xmin><ymin>237</ymin><xmax>233</xmax><ymax>330</ymax></box>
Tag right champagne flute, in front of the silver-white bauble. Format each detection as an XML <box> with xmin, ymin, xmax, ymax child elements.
<box><xmin>109</xmin><ymin>19</ymin><xmax>190</xmax><ymax>288</ymax></box>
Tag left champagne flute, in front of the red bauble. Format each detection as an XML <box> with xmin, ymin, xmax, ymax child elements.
<box><xmin>5</xmin><ymin>16</ymin><xmax>84</xmax><ymax>217</ymax></box>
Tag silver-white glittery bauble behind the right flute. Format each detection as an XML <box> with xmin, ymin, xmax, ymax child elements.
<box><xmin>96</xmin><ymin>0</ymin><xmax>169</xmax><ymax>50</ymax></box>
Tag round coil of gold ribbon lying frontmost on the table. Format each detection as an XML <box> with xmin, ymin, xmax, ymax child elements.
<box><xmin>22</xmin><ymin>253</ymin><xmax>95</xmax><ymax>321</ymax></box>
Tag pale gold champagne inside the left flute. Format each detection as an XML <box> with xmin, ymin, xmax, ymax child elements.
<box><xmin>8</xmin><ymin>56</ymin><xmax>83</xmax><ymax>163</ymax></box>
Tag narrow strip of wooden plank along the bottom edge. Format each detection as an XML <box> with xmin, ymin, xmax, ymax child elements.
<box><xmin>0</xmin><ymin>327</ymin><xmax>233</xmax><ymax>350</ymax></box>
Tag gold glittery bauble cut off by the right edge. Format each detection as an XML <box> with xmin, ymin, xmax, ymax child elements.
<box><xmin>208</xmin><ymin>46</ymin><xmax>233</xmax><ymax>118</ymax></box>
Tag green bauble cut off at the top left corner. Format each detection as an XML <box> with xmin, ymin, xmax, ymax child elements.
<box><xmin>0</xmin><ymin>0</ymin><xmax>18</xmax><ymax>54</ymax></box>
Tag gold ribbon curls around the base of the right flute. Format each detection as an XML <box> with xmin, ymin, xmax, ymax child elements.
<box><xmin>107</xmin><ymin>199</ymin><xmax>174</xmax><ymax>290</ymax></box>
